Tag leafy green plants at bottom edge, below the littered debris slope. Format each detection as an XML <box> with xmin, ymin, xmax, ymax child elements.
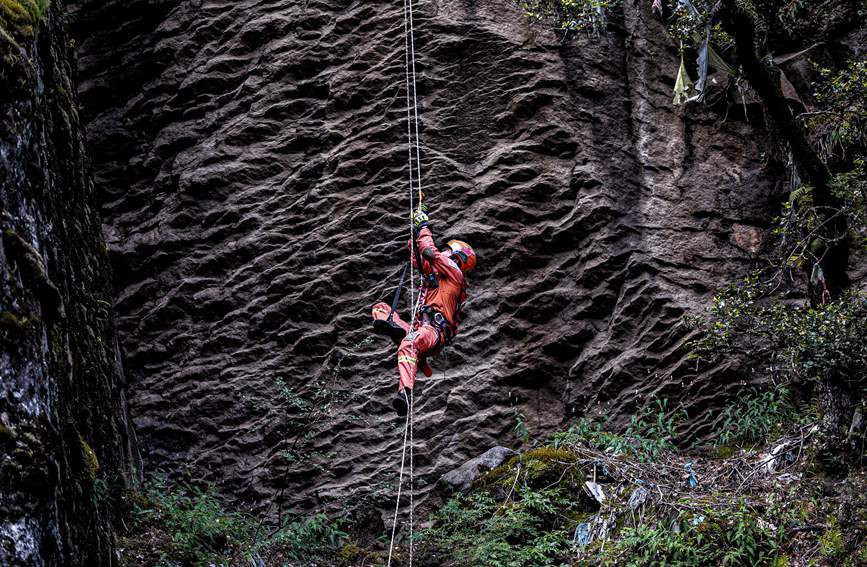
<box><xmin>616</xmin><ymin>504</ymin><xmax>780</xmax><ymax>567</ymax></box>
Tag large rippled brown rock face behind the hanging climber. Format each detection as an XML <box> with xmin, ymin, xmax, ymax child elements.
<box><xmin>74</xmin><ymin>0</ymin><xmax>848</xmax><ymax>513</ymax></box>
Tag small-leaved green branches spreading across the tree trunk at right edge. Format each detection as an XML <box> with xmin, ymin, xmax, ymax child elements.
<box><xmin>692</xmin><ymin>276</ymin><xmax>867</xmax><ymax>382</ymax></box>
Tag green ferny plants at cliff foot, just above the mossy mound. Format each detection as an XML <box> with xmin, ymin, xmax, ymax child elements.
<box><xmin>551</xmin><ymin>399</ymin><xmax>687</xmax><ymax>461</ymax></box>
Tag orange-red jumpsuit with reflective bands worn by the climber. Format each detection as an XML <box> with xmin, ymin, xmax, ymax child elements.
<box><xmin>373</xmin><ymin>227</ymin><xmax>467</xmax><ymax>391</ymax></box>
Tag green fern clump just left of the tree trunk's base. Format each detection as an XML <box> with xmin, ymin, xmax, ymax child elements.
<box><xmin>711</xmin><ymin>387</ymin><xmax>800</xmax><ymax>447</ymax></box>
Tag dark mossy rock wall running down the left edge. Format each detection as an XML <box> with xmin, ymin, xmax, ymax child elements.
<box><xmin>0</xmin><ymin>2</ymin><xmax>137</xmax><ymax>566</ymax></box>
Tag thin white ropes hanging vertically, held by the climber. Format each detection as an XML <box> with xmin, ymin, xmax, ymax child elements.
<box><xmin>388</xmin><ymin>0</ymin><xmax>425</xmax><ymax>567</ymax></box>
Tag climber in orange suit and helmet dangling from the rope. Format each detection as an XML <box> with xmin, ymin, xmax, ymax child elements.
<box><xmin>373</xmin><ymin>210</ymin><xmax>476</xmax><ymax>416</ymax></box>
